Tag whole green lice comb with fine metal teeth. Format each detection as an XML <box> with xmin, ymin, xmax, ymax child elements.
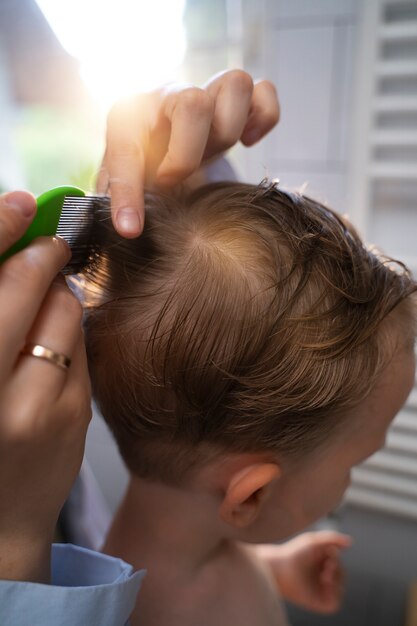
<box><xmin>0</xmin><ymin>186</ymin><xmax>110</xmax><ymax>274</ymax></box>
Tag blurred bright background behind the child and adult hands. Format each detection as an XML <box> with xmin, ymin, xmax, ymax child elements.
<box><xmin>0</xmin><ymin>0</ymin><xmax>417</xmax><ymax>626</ymax></box>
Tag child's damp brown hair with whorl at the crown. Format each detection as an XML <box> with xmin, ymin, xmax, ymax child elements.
<box><xmin>81</xmin><ymin>182</ymin><xmax>416</xmax><ymax>484</ymax></box>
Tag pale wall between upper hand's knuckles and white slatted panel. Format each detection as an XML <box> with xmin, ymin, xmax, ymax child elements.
<box><xmin>234</xmin><ymin>0</ymin><xmax>358</xmax><ymax>212</ymax></box>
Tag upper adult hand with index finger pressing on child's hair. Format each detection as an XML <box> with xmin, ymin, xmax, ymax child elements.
<box><xmin>97</xmin><ymin>70</ymin><xmax>279</xmax><ymax>237</ymax></box>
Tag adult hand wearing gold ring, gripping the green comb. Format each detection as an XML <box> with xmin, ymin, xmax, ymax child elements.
<box><xmin>0</xmin><ymin>192</ymin><xmax>91</xmax><ymax>582</ymax></box>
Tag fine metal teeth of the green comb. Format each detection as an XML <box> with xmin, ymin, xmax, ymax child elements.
<box><xmin>56</xmin><ymin>196</ymin><xmax>110</xmax><ymax>274</ymax></box>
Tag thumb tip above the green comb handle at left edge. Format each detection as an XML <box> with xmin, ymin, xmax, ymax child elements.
<box><xmin>0</xmin><ymin>191</ymin><xmax>36</xmax><ymax>254</ymax></box>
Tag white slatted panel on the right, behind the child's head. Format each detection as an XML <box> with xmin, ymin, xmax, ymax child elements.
<box><xmin>346</xmin><ymin>0</ymin><xmax>417</xmax><ymax>519</ymax></box>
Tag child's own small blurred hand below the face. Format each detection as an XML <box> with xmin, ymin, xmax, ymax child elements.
<box><xmin>258</xmin><ymin>531</ymin><xmax>352</xmax><ymax>613</ymax></box>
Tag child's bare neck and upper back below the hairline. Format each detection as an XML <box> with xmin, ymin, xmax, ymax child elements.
<box><xmin>103</xmin><ymin>478</ymin><xmax>284</xmax><ymax>626</ymax></box>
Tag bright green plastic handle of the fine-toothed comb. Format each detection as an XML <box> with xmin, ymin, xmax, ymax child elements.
<box><xmin>0</xmin><ymin>187</ymin><xmax>85</xmax><ymax>263</ymax></box>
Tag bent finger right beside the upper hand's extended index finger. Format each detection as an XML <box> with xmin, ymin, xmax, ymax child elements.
<box><xmin>157</xmin><ymin>87</ymin><xmax>214</xmax><ymax>185</ymax></box>
